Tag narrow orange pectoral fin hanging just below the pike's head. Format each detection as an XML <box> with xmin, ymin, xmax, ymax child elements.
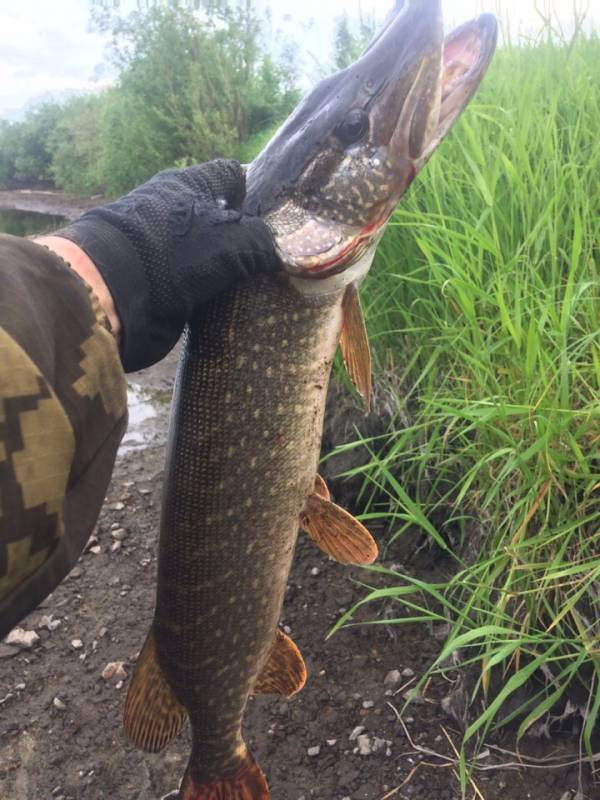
<box><xmin>340</xmin><ymin>283</ymin><xmax>371</xmax><ymax>411</ymax></box>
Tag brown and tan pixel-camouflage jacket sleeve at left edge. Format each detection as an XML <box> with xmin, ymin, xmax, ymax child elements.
<box><xmin>0</xmin><ymin>235</ymin><xmax>127</xmax><ymax>639</ymax></box>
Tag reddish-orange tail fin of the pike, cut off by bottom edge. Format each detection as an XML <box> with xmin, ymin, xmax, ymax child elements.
<box><xmin>179</xmin><ymin>751</ymin><xmax>271</xmax><ymax>800</ymax></box>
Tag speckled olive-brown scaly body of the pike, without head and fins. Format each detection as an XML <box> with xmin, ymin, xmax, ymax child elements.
<box><xmin>155</xmin><ymin>276</ymin><xmax>343</xmax><ymax>781</ymax></box>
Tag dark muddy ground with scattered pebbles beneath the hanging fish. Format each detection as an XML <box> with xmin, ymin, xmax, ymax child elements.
<box><xmin>0</xmin><ymin>346</ymin><xmax>600</xmax><ymax>800</ymax></box>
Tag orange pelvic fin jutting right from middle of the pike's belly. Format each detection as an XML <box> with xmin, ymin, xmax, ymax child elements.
<box><xmin>300</xmin><ymin>493</ymin><xmax>378</xmax><ymax>564</ymax></box>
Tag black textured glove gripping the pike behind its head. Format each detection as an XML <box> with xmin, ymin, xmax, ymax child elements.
<box><xmin>55</xmin><ymin>161</ymin><xmax>281</xmax><ymax>372</ymax></box>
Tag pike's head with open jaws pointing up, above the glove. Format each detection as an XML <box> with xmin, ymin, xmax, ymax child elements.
<box><xmin>245</xmin><ymin>0</ymin><xmax>497</xmax><ymax>279</ymax></box>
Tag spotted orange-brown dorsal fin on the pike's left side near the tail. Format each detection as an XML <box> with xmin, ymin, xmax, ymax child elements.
<box><xmin>123</xmin><ymin>628</ymin><xmax>187</xmax><ymax>753</ymax></box>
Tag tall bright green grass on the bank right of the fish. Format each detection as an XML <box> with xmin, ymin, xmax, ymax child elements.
<box><xmin>332</xmin><ymin>18</ymin><xmax>600</xmax><ymax>788</ymax></box>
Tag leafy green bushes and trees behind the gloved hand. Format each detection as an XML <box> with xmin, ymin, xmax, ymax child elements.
<box><xmin>0</xmin><ymin>0</ymin><xmax>298</xmax><ymax>195</ymax></box>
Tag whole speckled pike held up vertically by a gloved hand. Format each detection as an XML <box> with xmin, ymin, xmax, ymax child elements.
<box><xmin>124</xmin><ymin>0</ymin><xmax>496</xmax><ymax>800</ymax></box>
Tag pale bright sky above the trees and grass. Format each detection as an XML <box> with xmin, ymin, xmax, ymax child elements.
<box><xmin>0</xmin><ymin>0</ymin><xmax>600</xmax><ymax>119</ymax></box>
